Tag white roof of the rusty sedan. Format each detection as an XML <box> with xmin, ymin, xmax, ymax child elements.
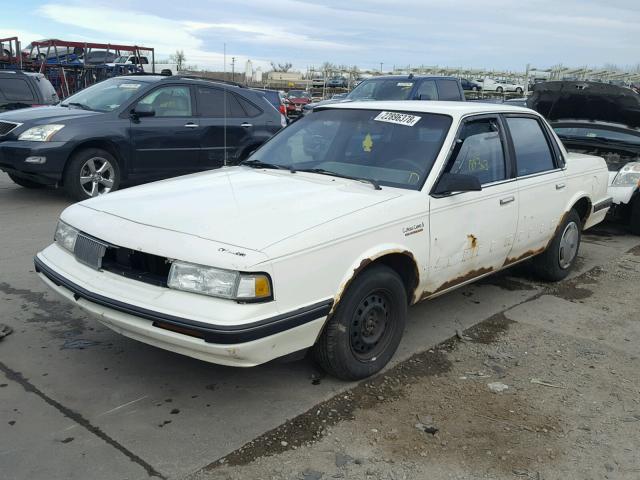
<box><xmin>317</xmin><ymin>100</ymin><xmax>540</xmax><ymax>117</ymax></box>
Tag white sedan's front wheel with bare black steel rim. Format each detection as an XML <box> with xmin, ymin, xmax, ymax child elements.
<box><xmin>313</xmin><ymin>265</ymin><xmax>407</xmax><ymax>380</ymax></box>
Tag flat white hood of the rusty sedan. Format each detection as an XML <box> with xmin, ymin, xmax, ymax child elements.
<box><xmin>75</xmin><ymin>167</ymin><xmax>401</xmax><ymax>251</ymax></box>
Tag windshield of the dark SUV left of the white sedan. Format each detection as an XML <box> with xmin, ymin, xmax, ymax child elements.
<box><xmin>60</xmin><ymin>77</ymin><xmax>145</xmax><ymax>112</ymax></box>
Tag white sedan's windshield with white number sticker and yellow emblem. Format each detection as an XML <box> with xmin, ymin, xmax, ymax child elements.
<box><xmin>247</xmin><ymin>109</ymin><xmax>451</xmax><ymax>190</ymax></box>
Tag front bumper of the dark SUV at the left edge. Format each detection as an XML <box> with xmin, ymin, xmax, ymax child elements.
<box><xmin>0</xmin><ymin>140</ymin><xmax>71</xmax><ymax>184</ymax></box>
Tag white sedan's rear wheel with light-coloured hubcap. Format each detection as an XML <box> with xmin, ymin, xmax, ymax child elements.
<box><xmin>532</xmin><ymin>210</ymin><xmax>582</xmax><ymax>282</ymax></box>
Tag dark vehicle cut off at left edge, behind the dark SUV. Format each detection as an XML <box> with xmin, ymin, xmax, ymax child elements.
<box><xmin>0</xmin><ymin>70</ymin><xmax>59</xmax><ymax>112</ymax></box>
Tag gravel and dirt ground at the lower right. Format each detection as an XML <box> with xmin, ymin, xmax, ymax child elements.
<box><xmin>188</xmin><ymin>247</ymin><xmax>640</xmax><ymax>480</ymax></box>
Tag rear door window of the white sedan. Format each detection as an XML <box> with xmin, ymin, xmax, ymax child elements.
<box><xmin>506</xmin><ymin>117</ymin><xmax>556</xmax><ymax>177</ymax></box>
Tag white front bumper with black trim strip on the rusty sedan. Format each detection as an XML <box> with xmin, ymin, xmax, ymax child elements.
<box><xmin>34</xmin><ymin>247</ymin><xmax>332</xmax><ymax>367</ymax></box>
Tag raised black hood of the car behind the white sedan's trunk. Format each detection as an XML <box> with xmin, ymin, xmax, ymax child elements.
<box><xmin>527</xmin><ymin>82</ymin><xmax>640</xmax><ymax>128</ymax></box>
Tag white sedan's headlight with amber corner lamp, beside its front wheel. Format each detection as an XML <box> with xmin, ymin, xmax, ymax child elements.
<box><xmin>167</xmin><ymin>261</ymin><xmax>272</xmax><ymax>301</ymax></box>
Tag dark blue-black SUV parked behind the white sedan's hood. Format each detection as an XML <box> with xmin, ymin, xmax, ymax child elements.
<box><xmin>0</xmin><ymin>75</ymin><xmax>286</xmax><ymax>200</ymax></box>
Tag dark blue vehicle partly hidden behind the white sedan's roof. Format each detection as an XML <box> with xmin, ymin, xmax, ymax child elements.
<box><xmin>304</xmin><ymin>74</ymin><xmax>465</xmax><ymax>115</ymax></box>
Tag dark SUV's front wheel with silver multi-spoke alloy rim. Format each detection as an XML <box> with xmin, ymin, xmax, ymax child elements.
<box><xmin>63</xmin><ymin>148</ymin><xmax>121</xmax><ymax>201</ymax></box>
